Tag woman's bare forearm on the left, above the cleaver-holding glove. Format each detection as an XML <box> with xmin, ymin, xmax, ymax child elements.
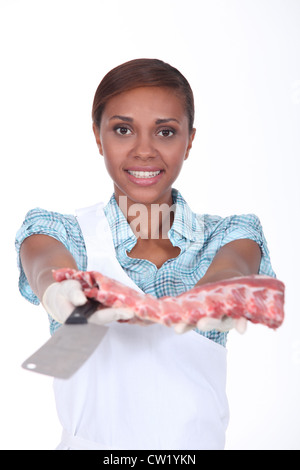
<box><xmin>20</xmin><ymin>235</ymin><xmax>78</xmax><ymax>300</ymax></box>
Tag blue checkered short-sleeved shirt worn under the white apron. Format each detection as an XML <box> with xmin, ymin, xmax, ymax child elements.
<box><xmin>15</xmin><ymin>189</ymin><xmax>275</xmax><ymax>346</ymax></box>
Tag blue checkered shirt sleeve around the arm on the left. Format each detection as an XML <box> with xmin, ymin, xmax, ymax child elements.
<box><xmin>15</xmin><ymin>208</ymin><xmax>87</xmax><ymax>305</ymax></box>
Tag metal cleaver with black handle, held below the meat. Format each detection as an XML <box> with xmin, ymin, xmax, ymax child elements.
<box><xmin>22</xmin><ymin>300</ymin><xmax>111</xmax><ymax>379</ymax></box>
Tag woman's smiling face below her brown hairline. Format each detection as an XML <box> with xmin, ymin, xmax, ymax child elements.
<box><xmin>94</xmin><ymin>87</ymin><xmax>195</xmax><ymax>204</ymax></box>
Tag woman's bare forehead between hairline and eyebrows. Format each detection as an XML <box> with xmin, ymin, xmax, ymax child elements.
<box><xmin>104</xmin><ymin>87</ymin><xmax>186</xmax><ymax>119</ymax></box>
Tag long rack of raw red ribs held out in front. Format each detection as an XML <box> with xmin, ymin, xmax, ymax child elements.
<box><xmin>53</xmin><ymin>269</ymin><xmax>285</xmax><ymax>329</ymax></box>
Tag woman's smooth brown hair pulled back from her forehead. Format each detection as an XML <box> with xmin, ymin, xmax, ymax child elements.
<box><xmin>92</xmin><ymin>59</ymin><xmax>195</xmax><ymax>132</ymax></box>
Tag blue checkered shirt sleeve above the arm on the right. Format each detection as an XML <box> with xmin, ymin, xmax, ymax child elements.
<box><xmin>221</xmin><ymin>214</ymin><xmax>276</xmax><ymax>277</ymax></box>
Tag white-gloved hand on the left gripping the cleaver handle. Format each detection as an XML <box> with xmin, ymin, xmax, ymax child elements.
<box><xmin>42</xmin><ymin>280</ymin><xmax>87</xmax><ymax>323</ymax></box>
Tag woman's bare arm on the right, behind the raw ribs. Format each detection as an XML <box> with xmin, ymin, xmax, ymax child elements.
<box><xmin>196</xmin><ymin>239</ymin><xmax>261</xmax><ymax>286</ymax></box>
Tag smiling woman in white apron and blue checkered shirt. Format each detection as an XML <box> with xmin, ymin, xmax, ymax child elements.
<box><xmin>16</xmin><ymin>59</ymin><xmax>275</xmax><ymax>449</ymax></box>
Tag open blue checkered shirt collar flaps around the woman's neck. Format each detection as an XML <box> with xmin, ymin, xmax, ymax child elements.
<box><xmin>104</xmin><ymin>189</ymin><xmax>203</xmax><ymax>248</ymax></box>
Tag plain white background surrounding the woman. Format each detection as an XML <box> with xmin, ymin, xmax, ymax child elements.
<box><xmin>0</xmin><ymin>0</ymin><xmax>300</xmax><ymax>449</ymax></box>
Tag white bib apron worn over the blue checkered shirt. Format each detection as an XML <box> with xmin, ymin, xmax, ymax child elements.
<box><xmin>54</xmin><ymin>204</ymin><xmax>228</xmax><ymax>450</ymax></box>
